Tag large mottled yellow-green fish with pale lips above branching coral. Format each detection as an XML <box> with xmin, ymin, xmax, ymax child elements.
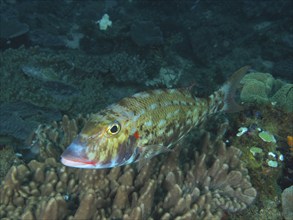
<box><xmin>61</xmin><ymin>66</ymin><xmax>250</xmax><ymax>169</ymax></box>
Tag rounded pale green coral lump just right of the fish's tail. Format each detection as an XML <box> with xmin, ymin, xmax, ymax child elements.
<box><xmin>240</xmin><ymin>72</ymin><xmax>274</xmax><ymax>104</ymax></box>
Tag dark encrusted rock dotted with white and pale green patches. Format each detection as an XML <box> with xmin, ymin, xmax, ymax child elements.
<box><xmin>227</xmin><ymin>102</ymin><xmax>293</xmax><ymax>220</ymax></box>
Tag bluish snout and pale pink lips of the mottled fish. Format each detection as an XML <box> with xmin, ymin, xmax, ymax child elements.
<box><xmin>61</xmin><ymin>137</ymin><xmax>97</xmax><ymax>168</ymax></box>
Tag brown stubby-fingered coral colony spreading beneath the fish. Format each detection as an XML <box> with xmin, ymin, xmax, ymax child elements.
<box><xmin>0</xmin><ymin>117</ymin><xmax>257</xmax><ymax>220</ymax></box>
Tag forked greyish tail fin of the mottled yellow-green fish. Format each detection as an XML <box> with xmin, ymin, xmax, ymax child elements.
<box><xmin>218</xmin><ymin>66</ymin><xmax>250</xmax><ymax>112</ymax></box>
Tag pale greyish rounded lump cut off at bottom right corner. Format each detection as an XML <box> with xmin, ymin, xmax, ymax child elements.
<box><xmin>282</xmin><ymin>186</ymin><xmax>293</xmax><ymax>220</ymax></box>
